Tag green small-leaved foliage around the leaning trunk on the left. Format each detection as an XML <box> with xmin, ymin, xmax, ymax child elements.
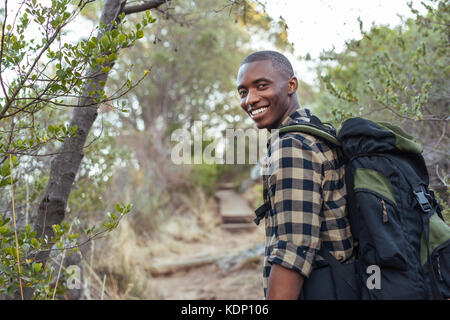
<box><xmin>0</xmin><ymin>0</ymin><xmax>155</xmax><ymax>299</ymax></box>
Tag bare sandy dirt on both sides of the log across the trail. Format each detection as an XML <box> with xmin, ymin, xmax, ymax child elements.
<box><xmin>149</xmin><ymin>222</ymin><xmax>263</xmax><ymax>300</ymax></box>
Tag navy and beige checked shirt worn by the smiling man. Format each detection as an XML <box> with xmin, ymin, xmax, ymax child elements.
<box><xmin>262</xmin><ymin>108</ymin><xmax>353</xmax><ymax>296</ymax></box>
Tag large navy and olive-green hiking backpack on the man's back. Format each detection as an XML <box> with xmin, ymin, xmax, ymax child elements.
<box><xmin>255</xmin><ymin>116</ymin><xmax>450</xmax><ymax>299</ymax></box>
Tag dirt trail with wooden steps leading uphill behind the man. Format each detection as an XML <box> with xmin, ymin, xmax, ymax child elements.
<box><xmin>150</xmin><ymin>189</ymin><xmax>264</xmax><ymax>300</ymax></box>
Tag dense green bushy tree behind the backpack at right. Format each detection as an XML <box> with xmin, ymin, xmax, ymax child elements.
<box><xmin>318</xmin><ymin>0</ymin><xmax>450</xmax><ymax>202</ymax></box>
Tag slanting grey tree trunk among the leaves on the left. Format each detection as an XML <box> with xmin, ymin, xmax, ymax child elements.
<box><xmin>19</xmin><ymin>0</ymin><xmax>164</xmax><ymax>300</ymax></box>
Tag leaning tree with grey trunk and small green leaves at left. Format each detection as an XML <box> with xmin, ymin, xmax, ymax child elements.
<box><xmin>0</xmin><ymin>0</ymin><xmax>165</xmax><ymax>299</ymax></box>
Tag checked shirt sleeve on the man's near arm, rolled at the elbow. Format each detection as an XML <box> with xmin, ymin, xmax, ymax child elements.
<box><xmin>268</xmin><ymin>137</ymin><xmax>326</xmax><ymax>278</ymax></box>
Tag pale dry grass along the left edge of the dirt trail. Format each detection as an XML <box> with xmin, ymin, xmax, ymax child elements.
<box><xmin>85</xmin><ymin>186</ymin><xmax>221</xmax><ymax>299</ymax></box>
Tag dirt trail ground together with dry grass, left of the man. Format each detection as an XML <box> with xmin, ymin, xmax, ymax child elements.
<box><xmin>89</xmin><ymin>182</ymin><xmax>265</xmax><ymax>300</ymax></box>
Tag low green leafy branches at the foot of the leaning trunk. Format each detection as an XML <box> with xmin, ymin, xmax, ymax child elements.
<box><xmin>0</xmin><ymin>204</ymin><xmax>131</xmax><ymax>299</ymax></box>
